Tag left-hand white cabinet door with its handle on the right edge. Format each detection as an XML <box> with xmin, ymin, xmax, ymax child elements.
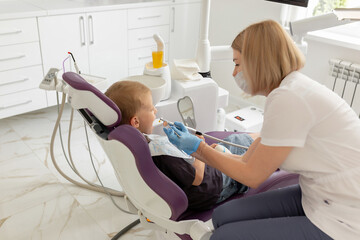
<box><xmin>38</xmin><ymin>14</ymin><xmax>89</xmax><ymax>73</ymax></box>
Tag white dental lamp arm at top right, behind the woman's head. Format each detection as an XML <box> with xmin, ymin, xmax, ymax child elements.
<box><xmin>290</xmin><ymin>8</ymin><xmax>360</xmax><ymax>53</ymax></box>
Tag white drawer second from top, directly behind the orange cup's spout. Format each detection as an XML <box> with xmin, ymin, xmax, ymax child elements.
<box><xmin>128</xmin><ymin>25</ymin><xmax>169</xmax><ymax>49</ymax></box>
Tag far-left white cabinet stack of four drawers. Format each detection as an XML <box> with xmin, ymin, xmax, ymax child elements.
<box><xmin>0</xmin><ymin>18</ymin><xmax>47</xmax><ymax>119</ymax></box>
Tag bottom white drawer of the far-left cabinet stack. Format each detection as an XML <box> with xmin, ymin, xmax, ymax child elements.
<box><xmin>0</xmin><ymin>89</ymin><xmax>47</xmax><ymax>119</ymax></box>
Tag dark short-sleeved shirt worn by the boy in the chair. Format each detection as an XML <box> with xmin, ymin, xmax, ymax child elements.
<box><xmin>152</xmin><ymin>155</ymin><xmax>223</xmax><ymax>211</ymax></box>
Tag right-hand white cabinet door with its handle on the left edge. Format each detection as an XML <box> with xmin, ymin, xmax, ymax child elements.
<box><xmin>86</xmin><ymin>10</ymin><xmax>128</xmax><ymax>84</ymax></box>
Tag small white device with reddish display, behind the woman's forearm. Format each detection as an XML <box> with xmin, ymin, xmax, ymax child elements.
<box><xmin>225</xmin><ymin>106</ymin><xmax>264</xmax><ymax>132</ymax></box>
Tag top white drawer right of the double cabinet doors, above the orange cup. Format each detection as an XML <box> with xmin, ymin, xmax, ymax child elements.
<box><xmin>128</xmin><ymin>6</ymin><xmax>170</xmax><ymax>29</ymax></box>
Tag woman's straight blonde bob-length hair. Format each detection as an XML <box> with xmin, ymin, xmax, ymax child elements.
<box><xmin>231</xmin><ymin>20</ymin><xmax>305</xmax><ymax>94</ymax></box>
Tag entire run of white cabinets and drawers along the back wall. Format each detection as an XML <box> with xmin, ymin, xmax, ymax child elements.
<box><xmin>0</xmin><ymin>0</ymin><xmax>201</xmax><ymax>119</ymax></box>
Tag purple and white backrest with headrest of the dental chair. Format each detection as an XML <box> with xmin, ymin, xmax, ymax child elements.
<box><xmin>63</xmin><ymin>72</ymin><xmax>188</xmax><ymax>220</ymax></box>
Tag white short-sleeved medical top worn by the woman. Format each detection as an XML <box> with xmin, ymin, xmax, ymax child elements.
<box><xmin>261</xmin><ymin>72</ymin><xmax>360</xmax><ymax>240</ymax></box>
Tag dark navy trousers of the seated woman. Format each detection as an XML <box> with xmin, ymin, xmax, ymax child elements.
<box><xmin>211</xmin><ymin>185</ymin><xmax>332</xmax><ymax>240</ymax></box>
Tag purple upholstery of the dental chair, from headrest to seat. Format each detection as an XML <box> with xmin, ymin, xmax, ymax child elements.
<box><xmin>63</xmin><ymin>72</ymin><xmax>298</xmax><ymax>239</ymax></box>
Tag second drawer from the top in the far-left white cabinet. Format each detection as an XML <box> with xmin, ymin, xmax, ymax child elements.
<box><xmin>0</xmin><ymin>42</ymin><xmax>41</xmax><ymax>71</ymax></box>
